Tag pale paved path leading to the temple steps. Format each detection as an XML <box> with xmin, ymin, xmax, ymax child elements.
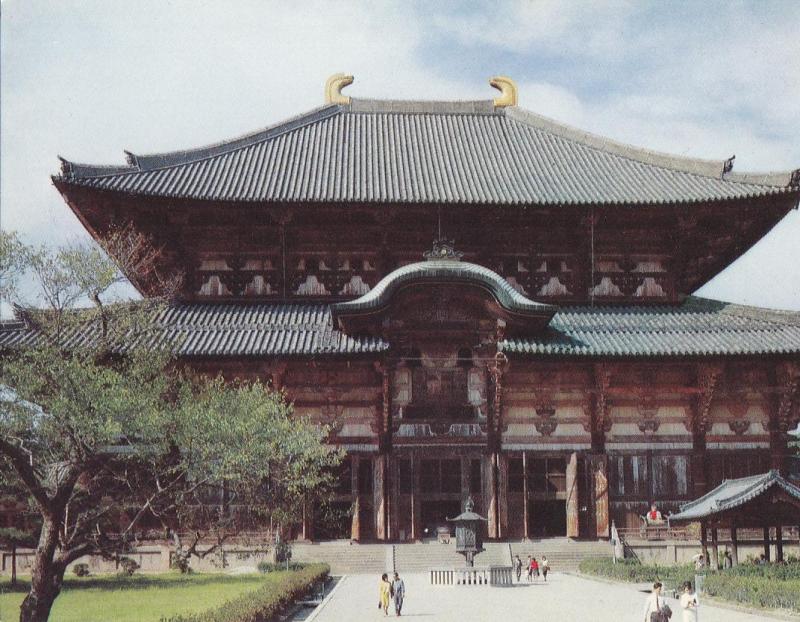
<box><xmin>308</xmin><ymin>573</ymin><xmax>770</xmax><ymax>622</ymax></box>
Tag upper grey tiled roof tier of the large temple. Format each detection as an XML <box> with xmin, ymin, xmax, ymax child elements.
<box><xmin>55</xmin><ymin>77</ymin><xmax>800</xmax><ymax>205</ymax></box>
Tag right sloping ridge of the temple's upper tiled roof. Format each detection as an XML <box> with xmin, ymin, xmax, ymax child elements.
<box><xmin>505</xmin><ymin>106</ymin><xmax>792</xmax><ymax>187</ymax></box>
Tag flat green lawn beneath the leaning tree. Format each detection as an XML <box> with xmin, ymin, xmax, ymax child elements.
<box><xmin>0</xmin><ymin>572</ymin><xmax>274</xmax><ymax>622</ymax></box>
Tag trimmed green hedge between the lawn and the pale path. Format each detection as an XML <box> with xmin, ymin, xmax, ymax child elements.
<box><xmin>161</xmin><ymin>564</ymin><xmax>330</xmax><ymax>622</ymax></box>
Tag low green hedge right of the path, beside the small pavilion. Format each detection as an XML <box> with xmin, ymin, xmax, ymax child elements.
<box><xmin>579</xmin><ymin>558</ymin><xmax>800</xmax><ymax>612</ymax></box>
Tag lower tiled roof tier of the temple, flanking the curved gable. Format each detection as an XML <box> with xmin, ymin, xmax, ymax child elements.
<box><xmin>0</xmin><ymin>297</ymin><xmax>800</xmax><ymax>358</ymax></box>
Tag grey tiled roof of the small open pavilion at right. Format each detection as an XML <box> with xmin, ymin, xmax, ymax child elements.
<box><xmin>669</xmin><ymin>470</ymin><xmax>800</xmax><ymax>523</ymax></box>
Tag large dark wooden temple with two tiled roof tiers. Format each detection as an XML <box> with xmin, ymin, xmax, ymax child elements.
<box><xmin>14</xmin><ymin>75</ymin><xmax>800</xmax><ymax>541</ymax></box>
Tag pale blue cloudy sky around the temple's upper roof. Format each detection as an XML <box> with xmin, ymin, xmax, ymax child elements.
<box><xmin>0</xmin><ymin>0</ymin><xmax>800</xmax><ymax>310</ymax></box>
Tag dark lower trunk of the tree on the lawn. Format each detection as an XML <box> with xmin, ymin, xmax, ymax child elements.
<box><xmin>19</xmin><ymin>519</ymin><xmax>66</xmax><ymax>622</ymax></box>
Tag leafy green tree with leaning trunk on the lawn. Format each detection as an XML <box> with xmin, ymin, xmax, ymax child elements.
<box><xmin>0</xmin><ymin>229</ymin><xmax>341</xmax><ymax>622</ymax></box>
